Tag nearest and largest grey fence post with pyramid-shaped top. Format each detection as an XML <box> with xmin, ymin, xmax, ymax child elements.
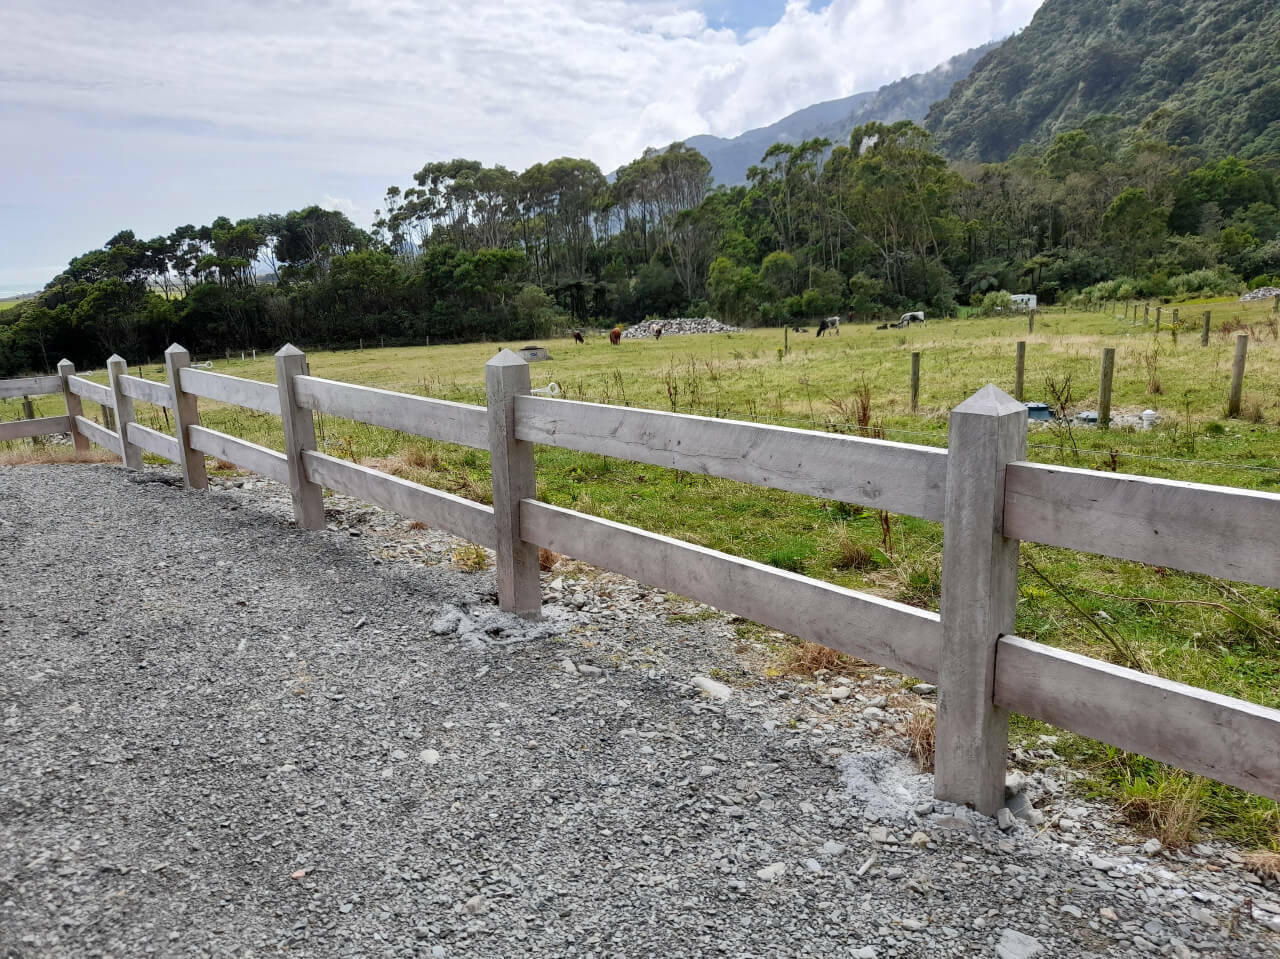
<box><xmin>934</xmin><ymin>385</ymin><xmax>1027</xmax><ymax>816</ymax></box>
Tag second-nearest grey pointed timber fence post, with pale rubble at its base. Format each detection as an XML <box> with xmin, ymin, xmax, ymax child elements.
<box><xmin>484</xmin><ymin>350</ymin><xmax>543</xmax><ymax>616</ymax></box>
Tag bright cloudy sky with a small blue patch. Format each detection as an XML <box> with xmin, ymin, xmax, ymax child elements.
<box><xmin>0</xmin><ymin>0</ymin><xmax>1041</xmax><ymax>297</ymax></box>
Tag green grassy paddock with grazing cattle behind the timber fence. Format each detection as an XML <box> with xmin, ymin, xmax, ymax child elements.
<box><xmin>0</xmin><ymin>295</ymin><xmax>1280</xmax><ymax>848</ymax></box>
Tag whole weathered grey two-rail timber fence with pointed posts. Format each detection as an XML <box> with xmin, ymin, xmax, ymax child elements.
<box><xmin>0</xmin><ymin>346</ymin><xmax>1280</xmax><ymax>814</ymax></box>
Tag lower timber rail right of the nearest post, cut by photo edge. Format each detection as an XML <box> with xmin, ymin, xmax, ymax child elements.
<box><xmin>995</xmin><ymin>636</ymin><xmax>1280</xmax><ymax>800</ymax></box>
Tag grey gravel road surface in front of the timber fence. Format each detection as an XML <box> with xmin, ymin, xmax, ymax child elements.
<box><xmin>0</xmin><ymin>466</ymin><xmax>1280</xmax><ymax>959</ymax></box>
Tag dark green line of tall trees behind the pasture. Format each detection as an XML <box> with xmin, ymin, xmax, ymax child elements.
<box><xmin>0</xmin><ymin>117</ymin><xmax>1280</xmax><ymax>375</ymax></box>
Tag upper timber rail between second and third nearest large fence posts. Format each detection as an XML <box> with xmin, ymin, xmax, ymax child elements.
<box><xmin>293</xmin><ymin>376</ymin><xmax>489</xmax><ymax>449</ymax></box>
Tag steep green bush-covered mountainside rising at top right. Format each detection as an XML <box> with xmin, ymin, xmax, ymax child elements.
<box><xmin>925</xmin><ymin>0</ymin><xmax>1280</xmax><ymax>161</ymax></box>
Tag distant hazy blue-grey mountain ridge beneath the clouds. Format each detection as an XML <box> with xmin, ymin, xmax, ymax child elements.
<box><xmin>685</xmin><ymin>41</ymin><xmax>1000</xmax><ymax>187</ymax></box>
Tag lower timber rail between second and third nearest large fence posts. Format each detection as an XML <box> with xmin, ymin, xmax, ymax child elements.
<box><xmin>302</xmin><ymin>451</ymin><xmax>498</xmax><ymax>549</ymax></box>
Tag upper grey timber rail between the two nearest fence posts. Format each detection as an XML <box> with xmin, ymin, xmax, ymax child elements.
<box><xmin>516</xmin><ymin>397</ymin><xmax>947</xmax><ymax>521</ymax></box>
